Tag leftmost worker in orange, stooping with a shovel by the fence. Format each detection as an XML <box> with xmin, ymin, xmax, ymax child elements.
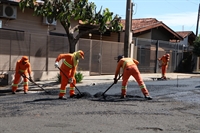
<box><xmin>12</xmin><ymin>56</ymin><xmax>33</xmax><ymax>94</ymax></box>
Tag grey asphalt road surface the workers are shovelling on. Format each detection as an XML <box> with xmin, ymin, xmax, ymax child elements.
<box><xmin>0</xmin><ymin>78</ymin><xmax>200</xmax><ymax>133</ymax></box>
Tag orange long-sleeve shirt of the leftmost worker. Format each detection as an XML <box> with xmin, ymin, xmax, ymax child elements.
<box><xmin>15</xmin><ymin>60</ymin><xmax>31</xmax><ymax>75</ymax></box>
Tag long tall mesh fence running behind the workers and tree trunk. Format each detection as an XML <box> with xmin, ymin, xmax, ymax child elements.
<box><xmin>0</xmin><ymin>30</ymin><xmax>183</xmax><ymax>78</ymax></box>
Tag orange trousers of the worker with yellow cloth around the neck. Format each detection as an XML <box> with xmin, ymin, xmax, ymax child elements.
<box><xmin>59</xmin><ymin>72</ymin><xmax>76</xmax><ymax>97</ymax></box>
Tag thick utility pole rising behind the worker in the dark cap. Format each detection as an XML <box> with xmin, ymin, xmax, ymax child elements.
<box><xmin>124</xmin><ymin>0</ymin><xmax>133</xmax><ymax>57</ymax></box>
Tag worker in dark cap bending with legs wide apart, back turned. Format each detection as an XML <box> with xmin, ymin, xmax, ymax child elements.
<box><xmin>114</xmin><ymin>56</ymin><xmax>152</xmax><ymax>100</ymax></box>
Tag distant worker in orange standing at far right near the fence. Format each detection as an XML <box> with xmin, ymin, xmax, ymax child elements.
<box><xmin>158</xmin><ymin>54</ymin><xmax>170</xmax><ymax>80</ymax></box>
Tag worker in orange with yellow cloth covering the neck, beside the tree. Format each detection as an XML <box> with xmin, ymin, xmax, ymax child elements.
<box><xmin>55</xmin><ymin>50</ymin><xmax>84</xmax><ymax>99</ymax></box>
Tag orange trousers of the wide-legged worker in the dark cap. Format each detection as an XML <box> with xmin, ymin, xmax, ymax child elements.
<box><xmin>122</xmin><ymin>64</ymin><xmax>149</xmax><ymax>96</ymax></box>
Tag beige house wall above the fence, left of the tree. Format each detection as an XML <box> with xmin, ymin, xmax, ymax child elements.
<box><xmin>0</xmin><ymin>4</ymin><xmax>78</xmax><ymax>34</ymax></box>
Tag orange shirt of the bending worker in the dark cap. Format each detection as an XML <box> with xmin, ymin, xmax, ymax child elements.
<box><xmin>115</xmin><ymin>58</ymin><xmax>139</xmax><ymax>78</ymax></box>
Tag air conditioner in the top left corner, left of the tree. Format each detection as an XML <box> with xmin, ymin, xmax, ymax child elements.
<box><xmin>0</xmin><ymin>4</ymin><xmax>17</xmax><ymax>19</ymax></box>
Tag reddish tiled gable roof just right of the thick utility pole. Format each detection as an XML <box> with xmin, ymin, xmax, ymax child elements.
<box><xmin>121</xmin><ymin>18</ymin><xmax>183</xmax><ymax>41</ymax></box>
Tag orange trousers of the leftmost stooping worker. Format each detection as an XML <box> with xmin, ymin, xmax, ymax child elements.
<box><xmin>12</xmin><ymin>73</ymin><xmax>28</xmax><ymax>92</ymax></box>
